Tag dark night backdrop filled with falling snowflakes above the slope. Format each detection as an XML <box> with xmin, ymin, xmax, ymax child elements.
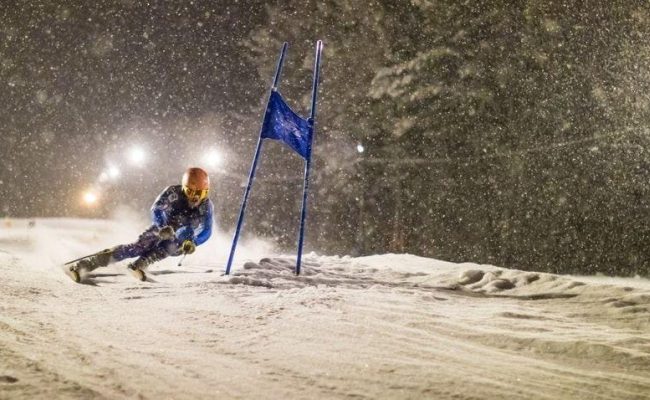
<box><xmin>0</xmin><ymin>0</ymin><xmax>650</xmax><ymax>275</ymax></box>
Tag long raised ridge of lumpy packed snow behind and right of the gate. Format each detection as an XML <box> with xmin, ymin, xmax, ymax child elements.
<box><xmin>230</xmin><ymin>253</ymin><xmax>650</xmax><ymax>330</ymax></box>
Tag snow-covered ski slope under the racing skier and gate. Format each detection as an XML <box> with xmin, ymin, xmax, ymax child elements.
<box><xmin>0</xmin><ymin>219</ymin><xmax>650</xmax><ymax>399</ymax></box>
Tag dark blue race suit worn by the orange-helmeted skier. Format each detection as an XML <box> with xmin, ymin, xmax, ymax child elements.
<box><xmin>112</xmin><ymin>185</ymin><xmax>214</xmax><ymax>262</ymax></box>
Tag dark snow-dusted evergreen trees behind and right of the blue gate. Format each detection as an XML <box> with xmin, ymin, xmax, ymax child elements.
<box><xmin>237</xmin><ymin>0</ymin><xmax>650</xmax><ymax>275</ymax></box>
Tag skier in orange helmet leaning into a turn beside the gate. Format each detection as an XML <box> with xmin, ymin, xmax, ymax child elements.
<box><xmin>69</xmin><ymin>168</ymin><xmax>214</xmax><ymax>282</ymax></box>
